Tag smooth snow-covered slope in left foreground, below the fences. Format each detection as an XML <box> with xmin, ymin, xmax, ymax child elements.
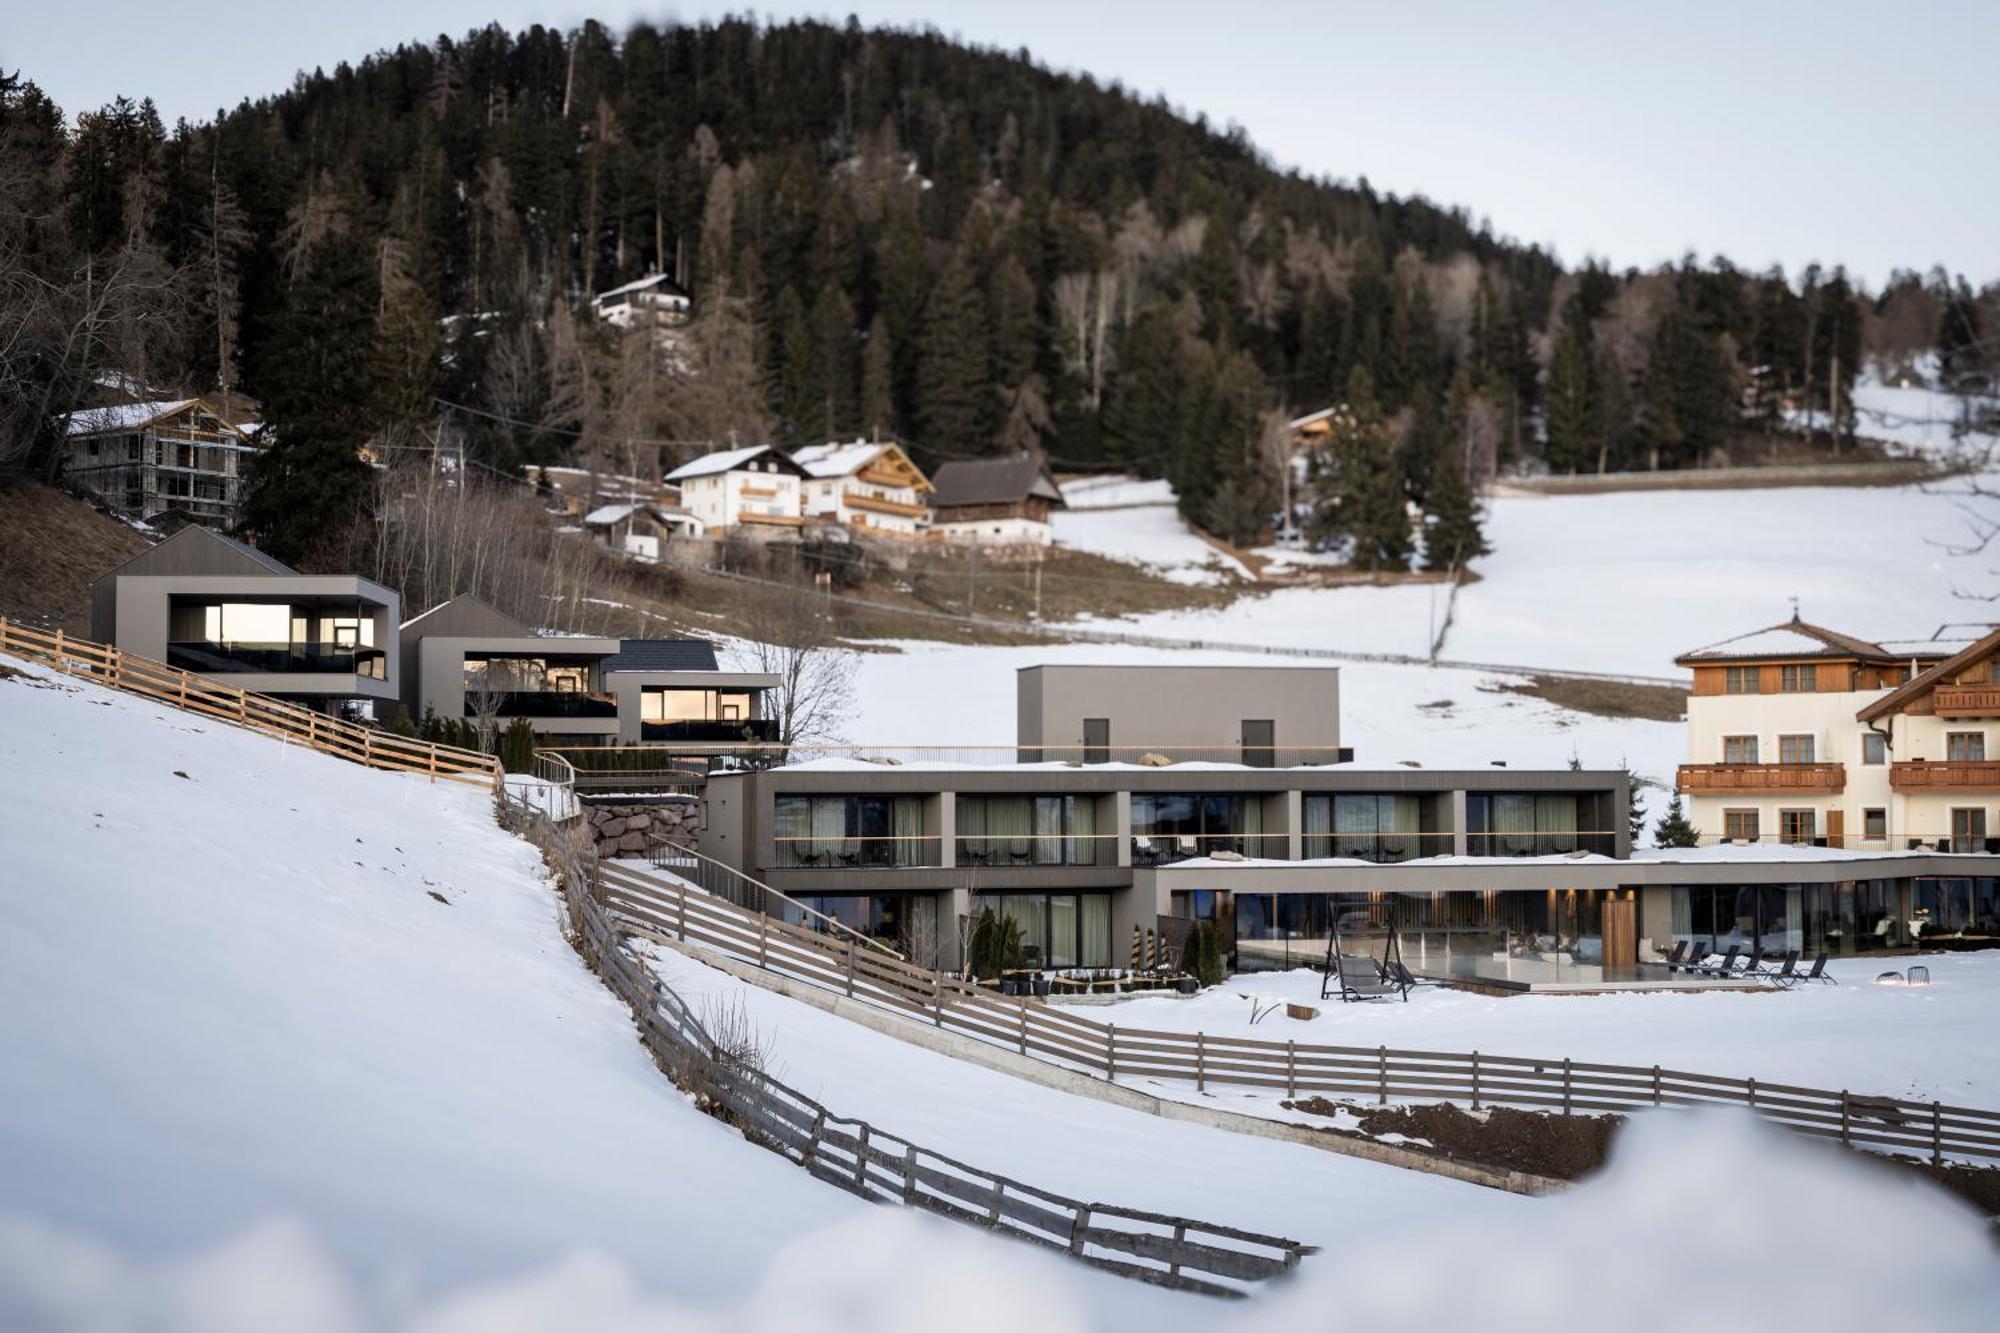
<box><xmin>0</xmin><ymin>658</ymin><xmax>1186</xmax><ymax>1331</ymax></box>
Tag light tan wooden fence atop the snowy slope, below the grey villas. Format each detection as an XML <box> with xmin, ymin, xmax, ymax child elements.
<box><xmin>0</xmin><ymin>620</ymin><xmax>502</xmax><ymax>791</ymax></box>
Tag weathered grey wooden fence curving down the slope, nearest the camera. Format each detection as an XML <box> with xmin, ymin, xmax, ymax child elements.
<box><xmin>510</xmin><ymin>805</ymin><xmax>1316</xmax><ymax>1297</ymax></box>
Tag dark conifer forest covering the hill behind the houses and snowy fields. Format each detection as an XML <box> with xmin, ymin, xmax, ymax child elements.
<box><xmin>0</xmin><ymin>20</ymin><xmax>2000</xmax><ymax>558</ymax></box>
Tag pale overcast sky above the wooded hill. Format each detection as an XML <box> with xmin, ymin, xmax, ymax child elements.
<box><xmin>0</xmin><ymin>0</ymin><xmax>2000</xmax><ymax>284</ymax></box>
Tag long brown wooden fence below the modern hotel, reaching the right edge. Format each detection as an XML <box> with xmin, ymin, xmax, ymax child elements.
<box><xmin>598</xmin><ymin>863</ymin><xmax>2000</xmax><ymax>1163</ymax></box>
